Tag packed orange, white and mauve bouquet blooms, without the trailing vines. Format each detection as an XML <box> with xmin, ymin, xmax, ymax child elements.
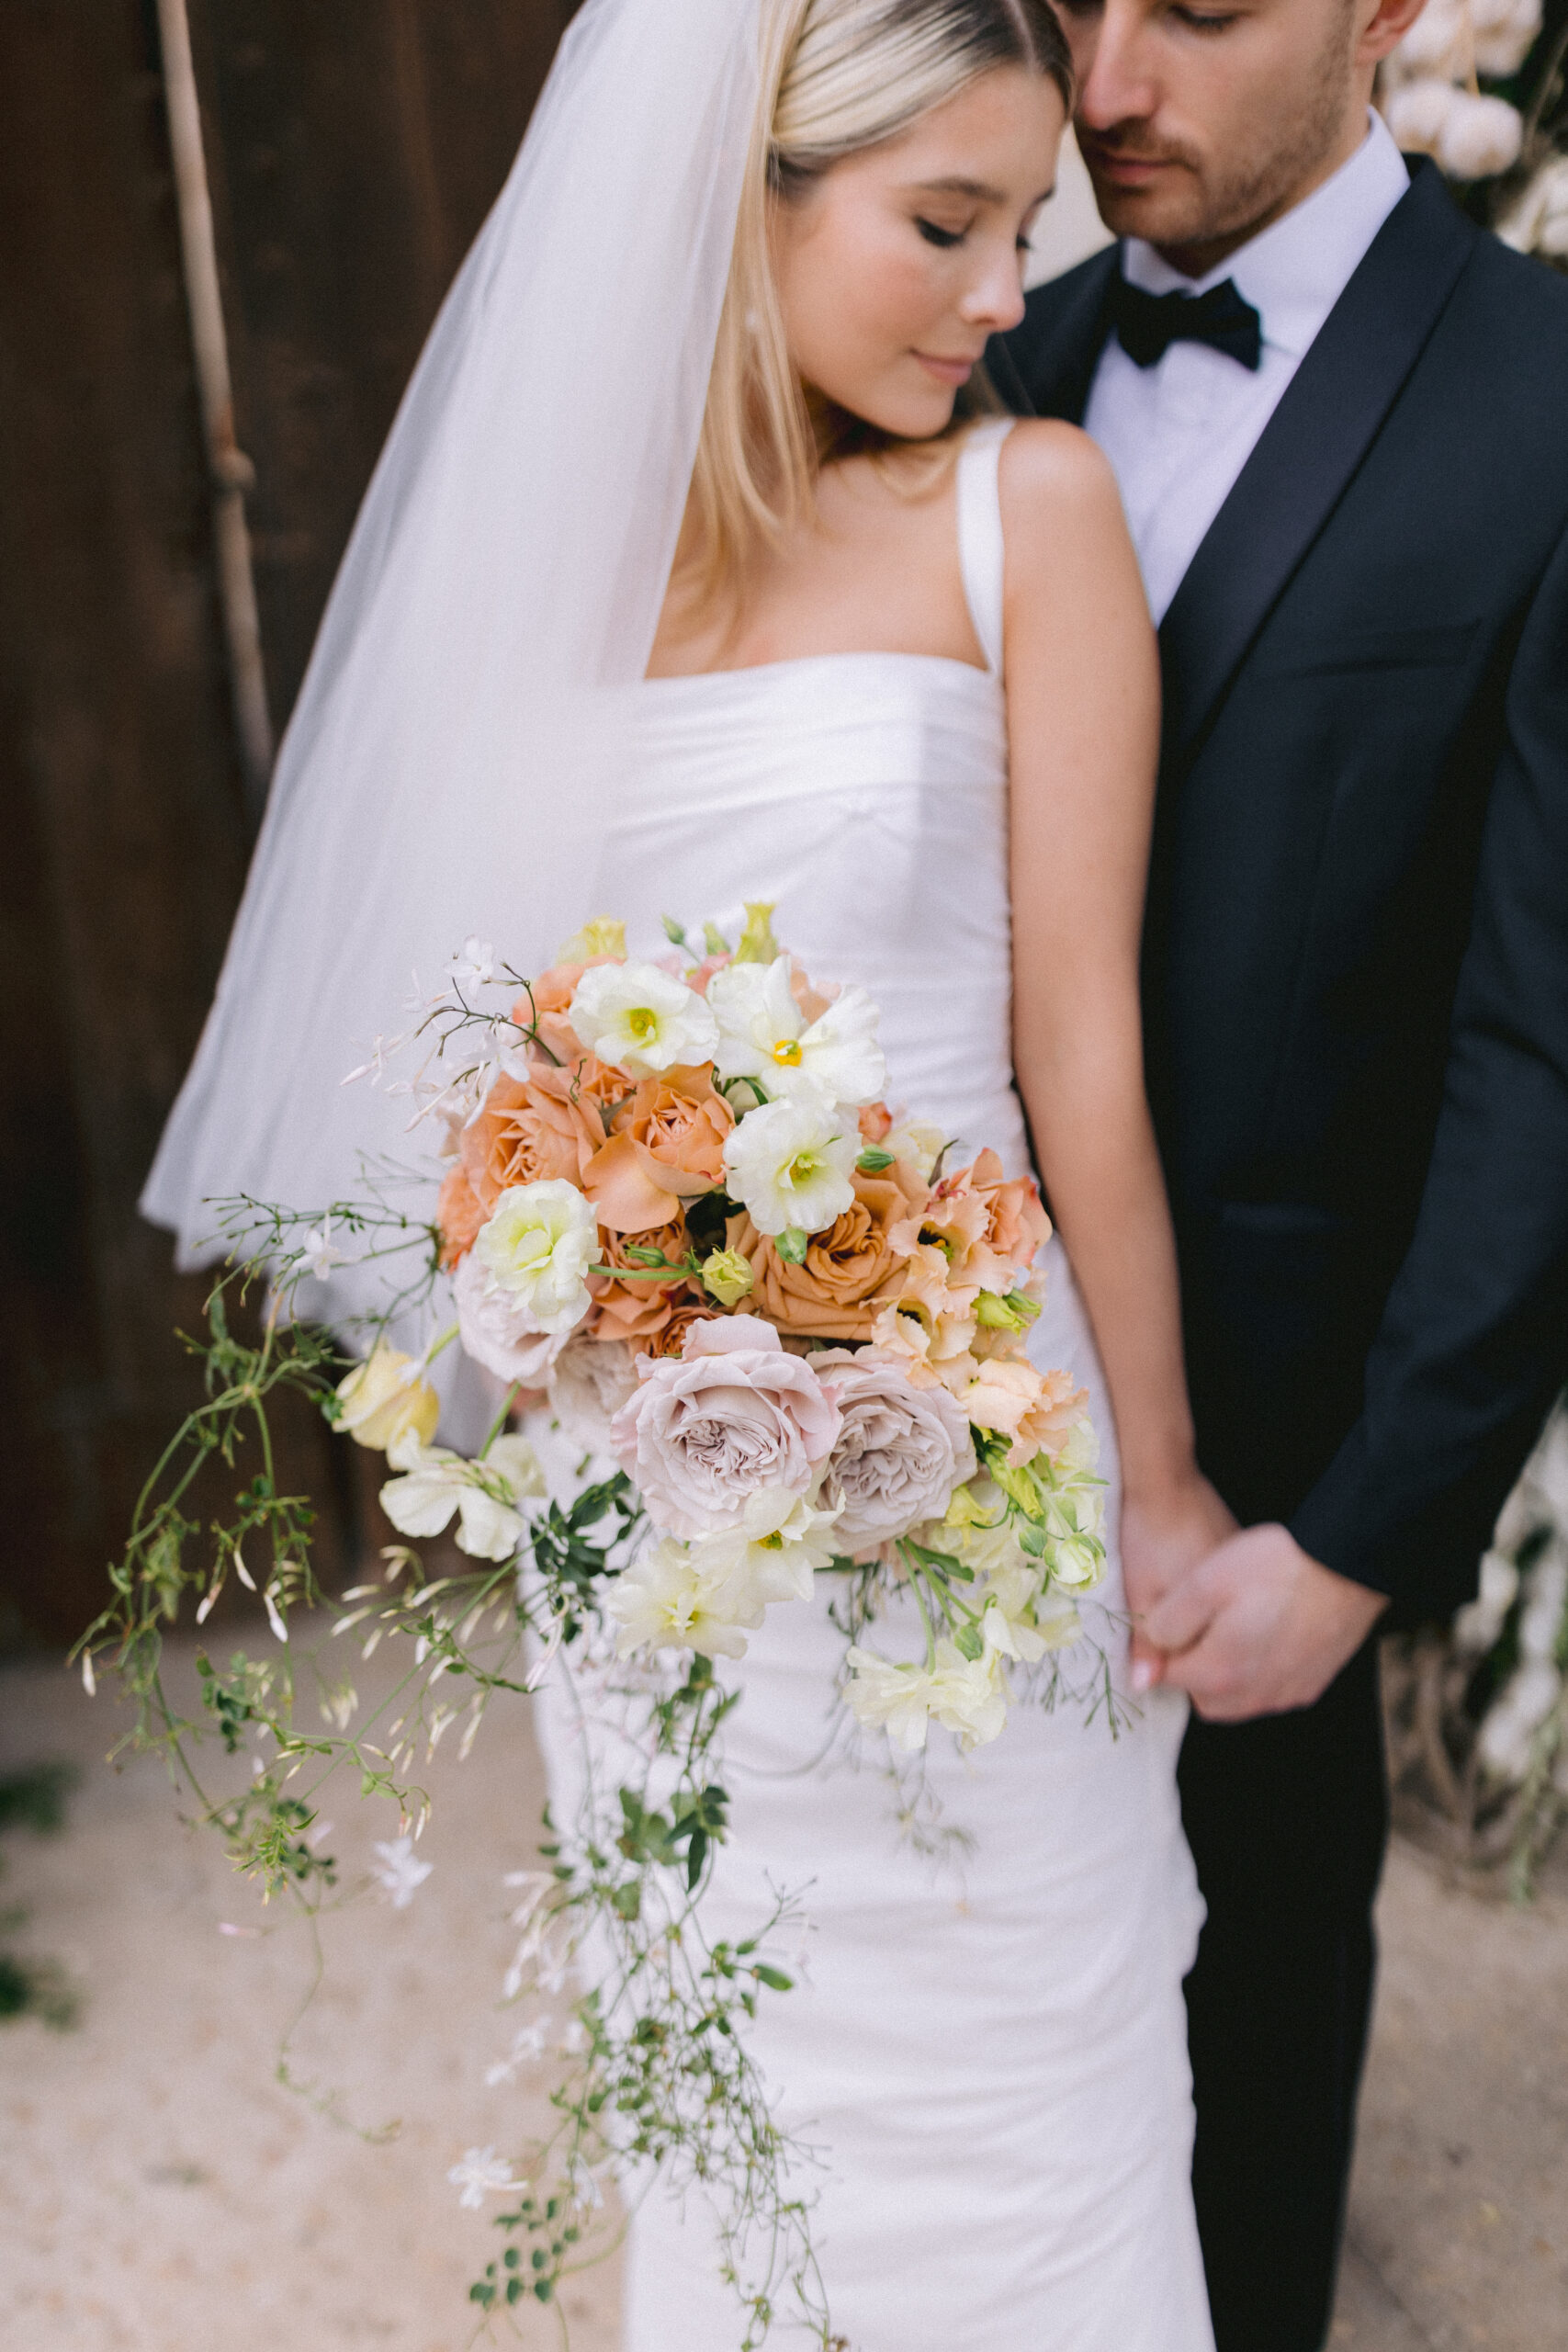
<box><xmin>385</xmin><ymin>908</ymin><xmax>1105</xmax><ymax>1747</ymax></box>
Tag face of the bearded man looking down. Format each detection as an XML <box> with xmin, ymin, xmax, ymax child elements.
<box><xmin>1060</xmin><ymin>0</ymin><xmax>1420</xmax><ymax>276</ymax></box>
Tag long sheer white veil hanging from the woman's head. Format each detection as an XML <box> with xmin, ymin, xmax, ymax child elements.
<box><xmin>141</xmin><ymin>0</ymin><xmax>760</xmax><ymax>1265</ymax></box>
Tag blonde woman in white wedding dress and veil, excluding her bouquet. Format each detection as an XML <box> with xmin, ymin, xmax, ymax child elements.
<box><xmin>146</xmin><ymin>0</ymin><xmax>1227</xmax><ymax>2352</ymax></box>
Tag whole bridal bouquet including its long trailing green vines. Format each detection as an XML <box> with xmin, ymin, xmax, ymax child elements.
<box><xmin>83</xmin><ymin>906</ymin><xmax>1114</xmax><ymax>2345</ymax></box>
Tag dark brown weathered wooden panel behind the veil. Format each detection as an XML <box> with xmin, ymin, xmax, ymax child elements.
<box><xmin>0</xmin><ymin>0</ymin><xmax>569</xmax><ymax>1644</ymax></box>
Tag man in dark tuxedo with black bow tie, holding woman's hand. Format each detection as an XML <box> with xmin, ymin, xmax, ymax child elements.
<box><xmin>987</xmin><ymin>0</ymin><xmax>1568</xmax><ymax>2352</ymax></box>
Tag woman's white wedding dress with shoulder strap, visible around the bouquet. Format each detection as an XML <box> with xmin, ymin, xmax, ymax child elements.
<box><xmin>538</xmin><ymin>424</ymin><xmax>1213</xmax><ymax>2352</ymax></box>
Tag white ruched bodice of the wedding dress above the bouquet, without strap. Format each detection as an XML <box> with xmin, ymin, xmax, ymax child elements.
<box><xmin>597</xmin><ymin>654</ymin><xmax>1025</xmax><ymax>1173</ymax></box>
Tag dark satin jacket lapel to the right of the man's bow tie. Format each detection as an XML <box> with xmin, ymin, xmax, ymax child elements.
<box><xmin>1159</xmin><ymin>163</ymin><xmax>1479</xmax><ymax>774</ymax></box>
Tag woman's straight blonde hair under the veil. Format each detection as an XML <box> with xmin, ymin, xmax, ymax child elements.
<box><xmin>677</xmin><ymin>0</ymin><xmax>1072</xmax><ymax>602</ymax></box>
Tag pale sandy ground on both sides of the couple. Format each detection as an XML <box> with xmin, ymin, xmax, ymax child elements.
<box><xmin>0</xmin><ymin>1663</ymin><xmax>1568</xmax><ymax>2352</ymax></box>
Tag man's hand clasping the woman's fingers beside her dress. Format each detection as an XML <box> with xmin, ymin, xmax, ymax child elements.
<box><xmin>1135</xmin><ymin>1524</ymin><xmax>1387</xmax><ymax>1724</ymax></box>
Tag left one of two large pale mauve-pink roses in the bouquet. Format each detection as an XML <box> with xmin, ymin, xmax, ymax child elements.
<box><xmin>609</xmin><ymin>1315</ymin><xmax>841</xmax><ymax>1538</ymax></box>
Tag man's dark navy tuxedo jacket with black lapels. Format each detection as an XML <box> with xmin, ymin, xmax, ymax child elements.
<box><xmin>987</xmin><ymin>164</ymin><xmax>1568</xmax><ymax>1621</ymax></box>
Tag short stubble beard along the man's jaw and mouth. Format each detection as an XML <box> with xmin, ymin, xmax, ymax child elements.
<box><xmin>1077</xmin><ymin>24</ymin><xmax>1354</xmax><ymax>277</ymax></box>
